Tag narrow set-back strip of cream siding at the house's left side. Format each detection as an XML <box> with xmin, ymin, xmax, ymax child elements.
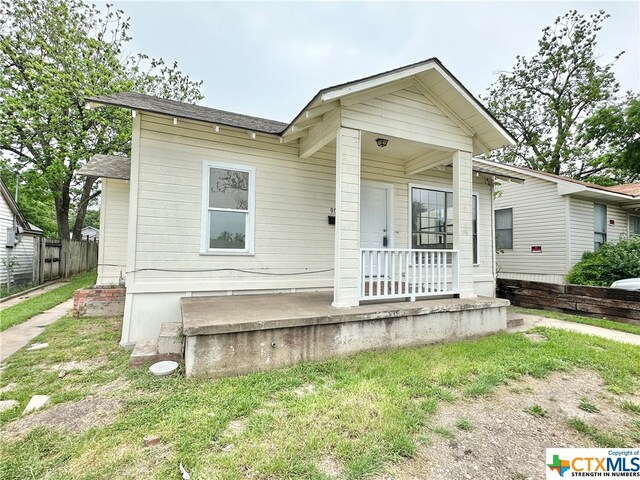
<box><xmin>96</xmin><ymin>178</ymin><xmax>129</xmax><ymax>285</ymax></box>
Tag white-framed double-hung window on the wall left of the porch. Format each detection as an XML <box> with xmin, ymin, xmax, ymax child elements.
<box><xmin>201</xmin><ymin>161</ymin><xmax>255</xmax><ymax>255</ymax></box>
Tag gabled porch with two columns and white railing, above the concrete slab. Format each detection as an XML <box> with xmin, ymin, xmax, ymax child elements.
<box><xmin>282</xmin><ymin>60</ymin><xmax>513</xmax><ymax>308</ymax></box>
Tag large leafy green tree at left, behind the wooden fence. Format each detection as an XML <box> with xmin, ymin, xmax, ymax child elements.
<box><xmin>0</xmin><ymin>0</ymin><xmax>203</xmax><ymax>239</ymax></box>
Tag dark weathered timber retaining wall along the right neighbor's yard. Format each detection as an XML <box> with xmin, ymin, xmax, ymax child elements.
<box><xmin>497</xmin><ymin>278</ymin><xmax>640</xmax><ymax>325</ymax></box>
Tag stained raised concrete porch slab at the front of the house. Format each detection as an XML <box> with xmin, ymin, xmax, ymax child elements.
<box><xmin>181</xmin><ymin>292</ymin><xmax>509</xmax><ymax>378</ymax></box>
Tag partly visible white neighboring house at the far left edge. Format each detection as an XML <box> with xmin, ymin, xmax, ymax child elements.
<box><xmin>0</xmin><ymin>180</ymin><xmax>42</xmax><ymax>285</ymax></box>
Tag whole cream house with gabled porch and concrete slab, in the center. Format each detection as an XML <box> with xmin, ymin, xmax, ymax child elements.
<box><xmin>83</xmin><ymin>58</ymin><xmax>521</xmax><ymax>376</ymax></box>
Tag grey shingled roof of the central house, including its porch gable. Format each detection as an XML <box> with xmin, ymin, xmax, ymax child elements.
<box><xmin>86</xmin><ymin>57</ymin><xmax>515</xmax><ymax>153</ymax></box>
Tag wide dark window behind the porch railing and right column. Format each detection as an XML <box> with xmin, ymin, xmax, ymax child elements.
<box><xmin>411</xmin><ymin>187</ymin><xmax>479</xmax><ymax>264</ymax></box>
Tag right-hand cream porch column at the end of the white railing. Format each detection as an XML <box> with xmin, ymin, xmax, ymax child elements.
<box><xmin>453</xmin><ymin>150</ymin><xmax>476</xmax><ymax>298</ymax></box>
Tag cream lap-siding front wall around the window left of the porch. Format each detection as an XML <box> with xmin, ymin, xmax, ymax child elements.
<box><xmin>136</xmin><ymin>115</ymin><xmax>335</xmax><ymax>291</ymax></box>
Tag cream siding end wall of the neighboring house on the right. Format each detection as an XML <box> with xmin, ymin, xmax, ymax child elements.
<box><xmin>495</xmin><ymin>177</ymin><xmax>568</xmax><ymax>279</ymax></box>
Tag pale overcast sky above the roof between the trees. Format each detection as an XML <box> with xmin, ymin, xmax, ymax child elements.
<box><xmin>115</xmin><ymin>1</ymin><xmax>640</xmax><ymax>122</ymax></box>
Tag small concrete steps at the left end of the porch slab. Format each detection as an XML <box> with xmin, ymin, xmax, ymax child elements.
<box><xmin>129</xmin><ymin>322</ymin><xmax>184</xmax><ymax>367</ymax></box>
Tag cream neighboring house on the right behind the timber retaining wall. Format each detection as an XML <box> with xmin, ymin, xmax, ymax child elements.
<box><xmin>478</xmin><ymin>160</ymin><xmax>640</xmax><ymax>284</ymax></box>
